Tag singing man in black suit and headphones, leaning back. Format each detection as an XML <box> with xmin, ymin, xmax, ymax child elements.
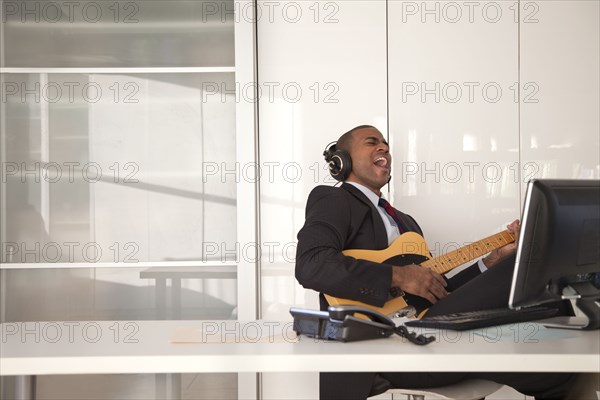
<box><xmin>296</xmin><ymin>125</ymin><xmax>574</xmax><ymax>400</ymax></box>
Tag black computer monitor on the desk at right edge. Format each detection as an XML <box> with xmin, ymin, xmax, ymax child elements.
<box><xmin>509</xmin><ymin>179</ymin><xmax>600</xmax><ymax>329</ymax></box>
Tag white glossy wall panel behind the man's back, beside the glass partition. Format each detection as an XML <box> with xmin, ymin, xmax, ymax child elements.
<box><xmin>258</xmin><ymin>0</ymin><xmax>387</xmax><ymax>399</ymax></box>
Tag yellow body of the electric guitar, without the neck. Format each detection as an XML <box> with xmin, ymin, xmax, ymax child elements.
<box><xmin>325</xmin><ymin>232</ymin><xmax>431</xmax><ymax>317</ymax></box>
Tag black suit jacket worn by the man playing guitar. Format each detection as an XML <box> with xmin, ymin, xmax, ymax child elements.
<box><xmin>296</xmin><ymin>183</ymin><xmax>480</xmax><ymax>307</ymax></box>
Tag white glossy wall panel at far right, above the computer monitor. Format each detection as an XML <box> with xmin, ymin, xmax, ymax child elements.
<box><xmin>520</xmin><ymin>0</ymin><xmax>600</xmax><ymax>193</ymax></box>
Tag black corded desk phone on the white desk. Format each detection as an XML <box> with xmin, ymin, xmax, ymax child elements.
<box><xmin>290</xmin><ymin>306</ymin><xmax>434</xmax><ymax>344</ymax></box>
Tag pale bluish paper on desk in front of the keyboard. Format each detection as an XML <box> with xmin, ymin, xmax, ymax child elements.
<box><xmin>472</xmin><ymin>322</ymin><xmax>575</xmax><ymax>343</ymax></box>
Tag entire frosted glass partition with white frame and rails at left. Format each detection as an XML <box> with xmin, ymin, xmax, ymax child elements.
<box><xmin>0</xmin><ymin>0</ymin><xmax>251</xmax><ymax>398</ymax></box>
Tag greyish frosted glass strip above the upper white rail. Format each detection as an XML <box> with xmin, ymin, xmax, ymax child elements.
<box><xmin>2</xmin><ymin>0</ymin><xmax>235</xmax><ymax>68</ymax></box>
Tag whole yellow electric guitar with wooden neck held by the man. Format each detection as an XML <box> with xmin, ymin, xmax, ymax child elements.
<box><xmin>325</xmin><ymin>231</ymin><xmax>515</xmax><ymax>318</ymax></box>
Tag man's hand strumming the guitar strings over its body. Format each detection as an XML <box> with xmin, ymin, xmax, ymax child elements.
<box><xmin>392</xmin><ymin>264</ymin><xmax>448</xmax><ymax>304</ymax></box>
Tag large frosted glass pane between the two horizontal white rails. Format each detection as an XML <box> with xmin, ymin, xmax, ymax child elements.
<box><xmin>2</xmin><ymin>73</ymin><xmax>236</xmax><ymax>263</ymax></box>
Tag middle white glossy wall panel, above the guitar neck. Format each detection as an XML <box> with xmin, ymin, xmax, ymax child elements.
<box><xmin>389</xmin><ymin>1</ymin><xmax>519</xmax><ymax>254</ymax></box>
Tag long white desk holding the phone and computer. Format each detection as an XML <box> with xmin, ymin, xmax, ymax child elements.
<box><xmin>0</xmin><ymin>321</ymin><xmax>600</xmax><ymax>398</ymax></box>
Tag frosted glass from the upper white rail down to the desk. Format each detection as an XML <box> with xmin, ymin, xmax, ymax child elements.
<box><xmin>0</xmin><ymin>72</ymin><xmax>237</xmax><ymax>320</ymax></box>
